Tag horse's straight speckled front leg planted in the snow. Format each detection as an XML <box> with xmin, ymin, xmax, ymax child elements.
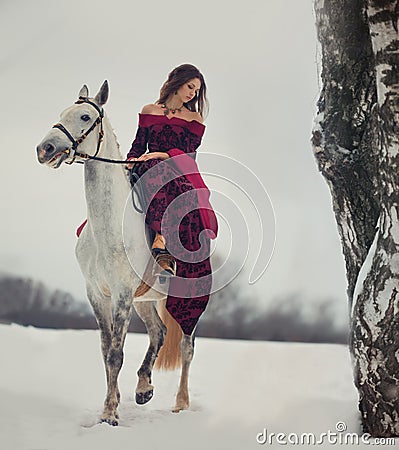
<box><xmin>101</xmin><ymin>290</ymin><xmax>133</xmax><ymax>426</ymax></box>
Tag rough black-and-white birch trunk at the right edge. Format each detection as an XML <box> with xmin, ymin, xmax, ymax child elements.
<box><xmin>312</xmin><ymin>0</ymin><xmax>399</xmax><ymax>437</ymax></box>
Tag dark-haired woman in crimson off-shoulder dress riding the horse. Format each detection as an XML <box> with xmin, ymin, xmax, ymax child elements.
<box><xmin>127</xmin><ymin>64</ymin><xmax>218</xmax><ymax>335</ymax></box>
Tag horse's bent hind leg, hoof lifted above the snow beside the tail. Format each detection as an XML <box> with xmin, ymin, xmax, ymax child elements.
<box><xmin>134</xmin><ymin>301</ymin><xmax>166</xmax><ymax>405</ymax></box>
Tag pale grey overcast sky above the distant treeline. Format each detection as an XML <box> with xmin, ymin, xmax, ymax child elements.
<box><xmin>0</xmin><ymin>0</ymin><xmax>346</xmax><ymax>322</ymax></box>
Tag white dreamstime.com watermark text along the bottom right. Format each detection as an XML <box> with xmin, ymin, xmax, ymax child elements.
<box><xmin>256</xmin><ymin>422</ymin><xmax>395</xmax><ymax>445</ymax></box>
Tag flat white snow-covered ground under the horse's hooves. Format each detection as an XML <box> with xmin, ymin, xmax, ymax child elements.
<box><xmin>0</xmin><ymin>325</ymin><xmax>399</xmax><ymax>450</ymax></box>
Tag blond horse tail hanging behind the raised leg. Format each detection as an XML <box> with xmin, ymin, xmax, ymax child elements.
<box><xmin>155</xmin><ymin>299</ymin><xmax>183</xmax><ymax>370</ymax></box>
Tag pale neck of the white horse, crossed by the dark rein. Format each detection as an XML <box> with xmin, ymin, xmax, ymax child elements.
<box><xmin>85</xmin><ymin>116</ymin><xmax>134</xmax><ymax>234</ymax></box>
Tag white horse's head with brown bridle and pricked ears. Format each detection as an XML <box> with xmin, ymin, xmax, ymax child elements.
<box><xmin>36</xmin><ymin>81</ymin><xmax>109</xmax><ymax>169</ymax></box>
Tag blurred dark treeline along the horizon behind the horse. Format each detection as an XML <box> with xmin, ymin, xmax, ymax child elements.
<box><xmin>0</xmin><ymin>275</ymin><xmax>347</xmax><ymax>343</ymax></box>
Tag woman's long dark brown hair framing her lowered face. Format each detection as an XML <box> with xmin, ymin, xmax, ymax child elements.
<box><xmin>157</xmin><ymin>64</ymin><xmax>208</xmax><ymax>117</ymax></box>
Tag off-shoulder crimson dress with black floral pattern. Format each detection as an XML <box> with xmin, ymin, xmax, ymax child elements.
<box><xmin>127</xmin><ymin>114</ymin><xmax>218</xmax><ymax>335</ymax></box>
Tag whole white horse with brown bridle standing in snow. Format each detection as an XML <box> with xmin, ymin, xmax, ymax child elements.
<box><xmin>37</xmin><ymin>81</ymin><xmax>194</xmax><ymax>425</ymax></box>
